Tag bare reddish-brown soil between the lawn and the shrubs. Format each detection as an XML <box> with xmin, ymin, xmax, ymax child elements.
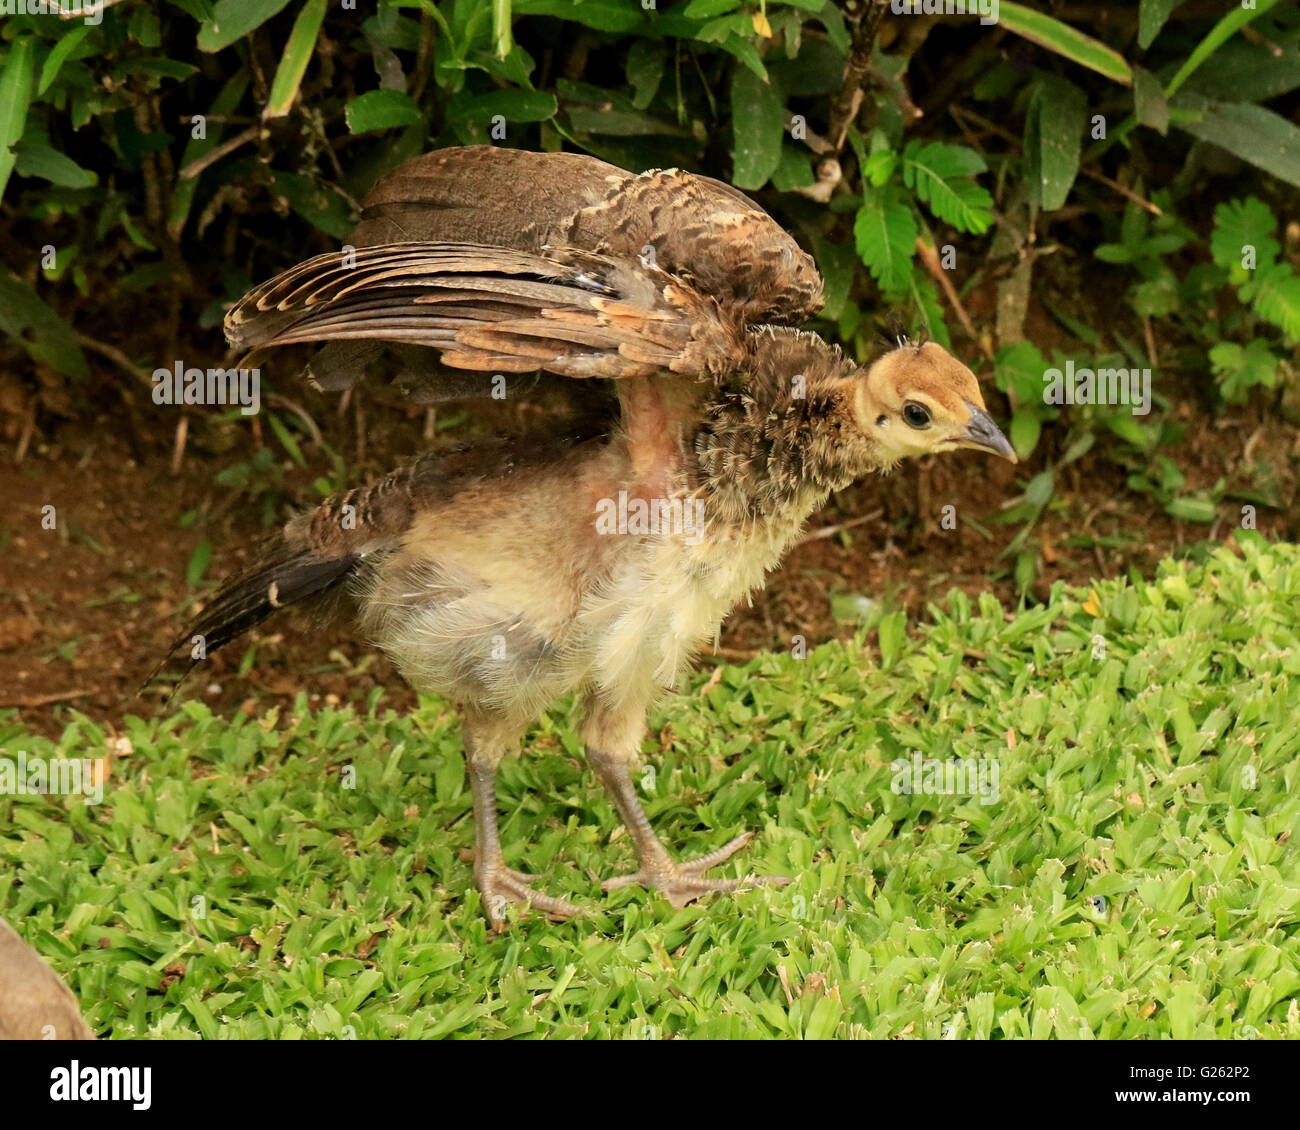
<box><xmin>0</xmin><ymin>363</ymin><xmax>1300</xmax><ymax>736</ymax></box>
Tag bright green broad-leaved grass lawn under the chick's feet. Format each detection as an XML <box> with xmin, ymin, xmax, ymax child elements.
<box><xmin>0</xmin><ymin>536</ymin><xmax>1300</xmax><ymax>1039</ymax></box>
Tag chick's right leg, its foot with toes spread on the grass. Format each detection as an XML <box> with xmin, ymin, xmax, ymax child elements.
<box><xmin>584</xmin><ymin>706</ymin><xmax>790</xmax><ymax>908</ymax></box>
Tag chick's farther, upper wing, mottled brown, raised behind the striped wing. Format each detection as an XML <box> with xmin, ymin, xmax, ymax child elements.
<box><xmin>352</xmin><ymin>146</ymin><xmax>822</xmax><ymax>325</ymax></box>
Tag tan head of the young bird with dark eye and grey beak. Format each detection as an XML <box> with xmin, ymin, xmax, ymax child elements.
<box><xmin>853</xmin><ymin>342</ymin><xmax>1018</xmax><ymax>463</ymax></box>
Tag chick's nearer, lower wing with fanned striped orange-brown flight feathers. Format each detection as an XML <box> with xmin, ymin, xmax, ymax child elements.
<box><xmin>226</xmin><ymin>242</ymin><xmax>744</xmax><ymax>380</ymax></box>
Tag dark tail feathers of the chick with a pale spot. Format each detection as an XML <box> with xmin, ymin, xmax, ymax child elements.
<box><xmin>142</xmin><ymin>545</ymin><xmax>360</xmax><ymax>693</ymax></box>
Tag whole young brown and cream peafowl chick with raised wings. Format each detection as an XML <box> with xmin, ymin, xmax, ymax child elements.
<box><xmin>170</xmin><ymin>148</ymin><xmax>1014</xmax><ymax>925</ymax></box>
